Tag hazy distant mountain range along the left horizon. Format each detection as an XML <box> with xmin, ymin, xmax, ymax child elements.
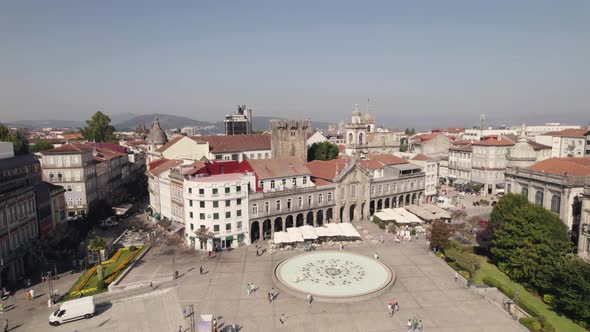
<box><xmin>7</xmin><ymin>113</ymin><xmax>328</xmax><ymax>134</ymax></box>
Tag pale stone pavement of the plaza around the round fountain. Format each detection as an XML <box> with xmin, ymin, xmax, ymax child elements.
<box><xmin>0</xmin><ymin>222</ymin><xmax>525</xmax><ymax>332</ymax></box>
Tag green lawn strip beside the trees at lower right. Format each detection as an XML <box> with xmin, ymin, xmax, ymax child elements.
<box><xmin>472</xmin><ymin>249</ymin><xmax>586</xmax><ymax>332</ymax></box>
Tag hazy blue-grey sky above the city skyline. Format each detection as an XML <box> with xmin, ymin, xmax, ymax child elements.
<box><xmin>0</xmin><ymin>0</ymin><xmax>590</xmax><ymax>127</ymax></box>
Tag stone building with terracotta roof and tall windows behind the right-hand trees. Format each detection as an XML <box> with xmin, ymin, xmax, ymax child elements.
<box><xmin>506</xmin><ymin>158</ymin><xmax>590</xmax><ymax>230</ymax></box>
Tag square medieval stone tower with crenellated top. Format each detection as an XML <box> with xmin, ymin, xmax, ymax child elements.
<box><xmin>270</xmin><ymin>120</ymin><xmax>313</xmax><ymax>162</ymax></box>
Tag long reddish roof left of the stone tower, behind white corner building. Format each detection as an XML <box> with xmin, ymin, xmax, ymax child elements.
<box><xmin>191</xmin><ymin>134</ymin><xmax>271</xmax><ymax>153</ymax></box>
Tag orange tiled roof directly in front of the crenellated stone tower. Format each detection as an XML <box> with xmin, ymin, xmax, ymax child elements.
<box><xmin>248</xmin><ymin>158</ymin><xmax>311</xmax><ymax>179</ymax></box>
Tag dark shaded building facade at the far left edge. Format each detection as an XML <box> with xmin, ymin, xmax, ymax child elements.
<box><xmin>0</xmin><ymin>147</ymin><xmax>41</xmax><ymax>286</ymax></box>
